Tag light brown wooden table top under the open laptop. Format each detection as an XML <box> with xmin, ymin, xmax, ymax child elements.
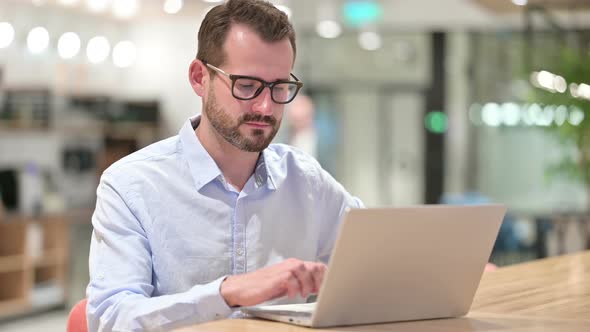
<box><xmin>179</xmin><ymin>251</ymin><xmax>590</xmax><ymax>332</ymax></box>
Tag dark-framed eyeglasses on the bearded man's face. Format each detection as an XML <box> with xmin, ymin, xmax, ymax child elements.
<box><xmin>203</xmin><ymin>61</ymin><xmax>303</xmax><ymax>104</ymax></box>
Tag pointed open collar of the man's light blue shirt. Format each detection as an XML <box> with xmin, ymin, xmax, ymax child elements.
<box><xmin>178</xmin><ymin>115</ymin><xmax>276</xmax><ymax>190</ymax></box>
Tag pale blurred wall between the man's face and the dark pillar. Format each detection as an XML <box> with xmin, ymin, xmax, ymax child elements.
<box><xmin>295</xmin><ymin>30</ymin><xmax>432</xmax><ymax>206</ymax></box>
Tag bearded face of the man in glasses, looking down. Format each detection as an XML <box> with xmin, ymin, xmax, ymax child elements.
<box><xmin>203</xmin><ymin>24</ymin><xmax>293</xmax><ymax>152</ymax></box>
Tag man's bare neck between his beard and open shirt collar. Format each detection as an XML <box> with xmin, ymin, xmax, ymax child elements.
<box><xmin>195</xmin><ymin>119</ymin><xmax>260</xmax><ymax>191</ymax></box>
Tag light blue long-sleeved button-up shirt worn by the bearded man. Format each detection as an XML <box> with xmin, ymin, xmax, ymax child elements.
<box><xmin>87</xmin><ymin>117</ymin><xmax>362</xmax><ymax>331</ymax></box>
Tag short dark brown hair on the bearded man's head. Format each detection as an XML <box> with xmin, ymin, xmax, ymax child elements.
<box><xmin>197</xmin><ymin>0</ymin><xmax>296</xmax><ymax>66</ymax></box>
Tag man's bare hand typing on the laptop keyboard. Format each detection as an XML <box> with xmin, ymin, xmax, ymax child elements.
<box><xmin>221</xmin><ymin>258</ymin><xmax>327</xmax><ymax>307</ymax></box>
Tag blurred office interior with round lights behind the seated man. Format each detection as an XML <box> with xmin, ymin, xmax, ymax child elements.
<box><xmin>0</xmin><ymin>0</ymin><xmax>590</xmax><ymax>331</ymax></box>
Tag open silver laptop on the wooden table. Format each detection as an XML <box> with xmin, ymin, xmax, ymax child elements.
<box><xmin>241</xmin><ymin>205</ymin><xmax>506</xmax><ymax>328</ymax></box>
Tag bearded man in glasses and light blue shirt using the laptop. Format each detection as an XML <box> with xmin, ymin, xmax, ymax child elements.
<box><xmin>87</xmin><ymin>0</ymin><xmax>362</xmax><ymax>331</ymax></box>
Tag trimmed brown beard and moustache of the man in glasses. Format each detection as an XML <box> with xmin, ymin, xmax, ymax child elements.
<box><xmin>203</xmin><ymin>89</ymin><xmax>281</xmax><ymax>152</ymax></box>
